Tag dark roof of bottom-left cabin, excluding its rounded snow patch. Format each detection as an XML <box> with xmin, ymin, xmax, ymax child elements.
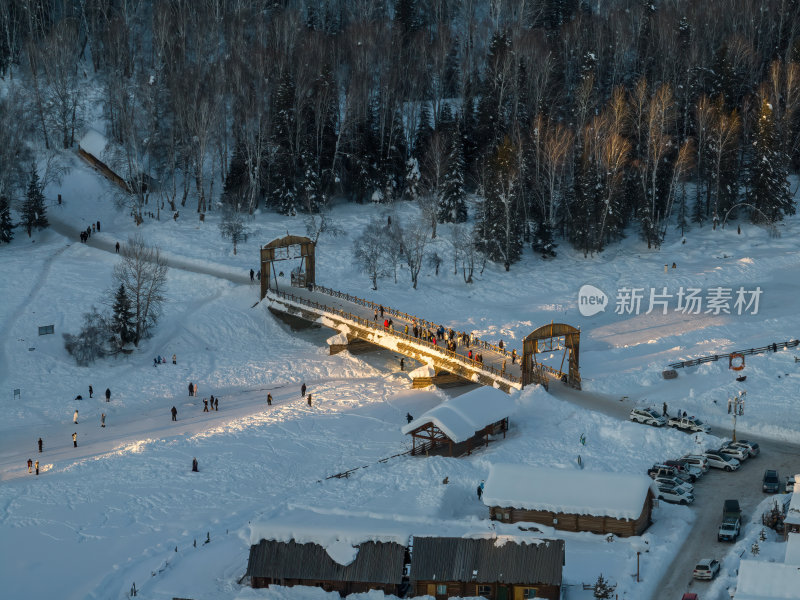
<box><xmin>247</xmin><ymin>540</ymin><xmax>406</xmax><ymax>584</ymax></box>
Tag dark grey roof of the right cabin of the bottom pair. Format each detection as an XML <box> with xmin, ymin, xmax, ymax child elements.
<box><xmin>411</xmin><ymin>536</ymin><xmax>564</xmax><ymax>585</ymax></box>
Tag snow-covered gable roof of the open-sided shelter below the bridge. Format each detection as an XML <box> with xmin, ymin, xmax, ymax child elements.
<box><xmin>402</xmin><ymin>387</ymin><xmax>516</xmax><ymax>442</ymax></box>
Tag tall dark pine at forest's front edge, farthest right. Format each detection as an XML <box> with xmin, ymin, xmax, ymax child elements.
<box><xmin>747</xmin><ymin>99</ymin><xmax>795</xmax><ymax>224</ymax></box>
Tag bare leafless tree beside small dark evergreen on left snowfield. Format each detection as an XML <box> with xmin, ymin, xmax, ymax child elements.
<box><xmin>114</xmin><ymin>235</ymin><xmax>168</xmax><ymax>346</ymax></box>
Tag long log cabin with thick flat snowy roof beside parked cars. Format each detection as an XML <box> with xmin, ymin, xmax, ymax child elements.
<box><xmin>482</xmin><ymin>464</ymin><xmax>654</xmax><ymax>537</ymax></box>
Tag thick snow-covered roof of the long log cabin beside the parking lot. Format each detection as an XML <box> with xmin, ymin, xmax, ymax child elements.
<box><xmin>483</xmin><ymin>464</ymin><xmax>652</xmax><ymax>519</ymax></box>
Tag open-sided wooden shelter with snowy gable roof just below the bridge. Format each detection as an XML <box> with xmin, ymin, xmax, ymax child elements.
<box><xmin>402</xmin><ymin>387</ymin><xmax>516</xmax><ymax>456</ymax></box>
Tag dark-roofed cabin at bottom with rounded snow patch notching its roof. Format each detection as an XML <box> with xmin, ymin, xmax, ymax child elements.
<box><xmin>245</xmin><ymin>539</ymin><xmax>407</xmax><ymax>596</ymax></box>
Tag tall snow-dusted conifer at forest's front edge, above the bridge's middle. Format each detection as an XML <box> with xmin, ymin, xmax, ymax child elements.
<box><xmin>476</xmin><ymin>136</ymin><xmax>523</xmax><ymax>271</ymax></box>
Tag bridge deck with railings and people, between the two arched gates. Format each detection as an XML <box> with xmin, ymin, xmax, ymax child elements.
<box><xmin>267</xmin><ymin>286</ymin><xmax>546</xmax><ymax>391</ymax></box>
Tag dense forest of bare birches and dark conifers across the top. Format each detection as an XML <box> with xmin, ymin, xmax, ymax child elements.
<box><xmin>0</xmin><ymin>0</ymin><xmax>800</xmax><ymax>268</ymax></box>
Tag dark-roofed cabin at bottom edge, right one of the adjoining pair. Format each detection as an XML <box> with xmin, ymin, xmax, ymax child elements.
<box><xmin>411</xmin><ymin>536</ymin><xmax>564</xmax><ymax>600</ymax></box>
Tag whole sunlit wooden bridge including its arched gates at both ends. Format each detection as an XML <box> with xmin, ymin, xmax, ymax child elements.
<box><xmin>261</xmin><ymin>236</ymin><xmax>580</xmax><ymax>392</ymax></box>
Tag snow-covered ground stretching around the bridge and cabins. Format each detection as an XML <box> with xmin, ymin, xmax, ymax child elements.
<box><xmin>0</xmin><ymin>159</ymin><xmax>800</xmax><ymax>600</ymax></box>
